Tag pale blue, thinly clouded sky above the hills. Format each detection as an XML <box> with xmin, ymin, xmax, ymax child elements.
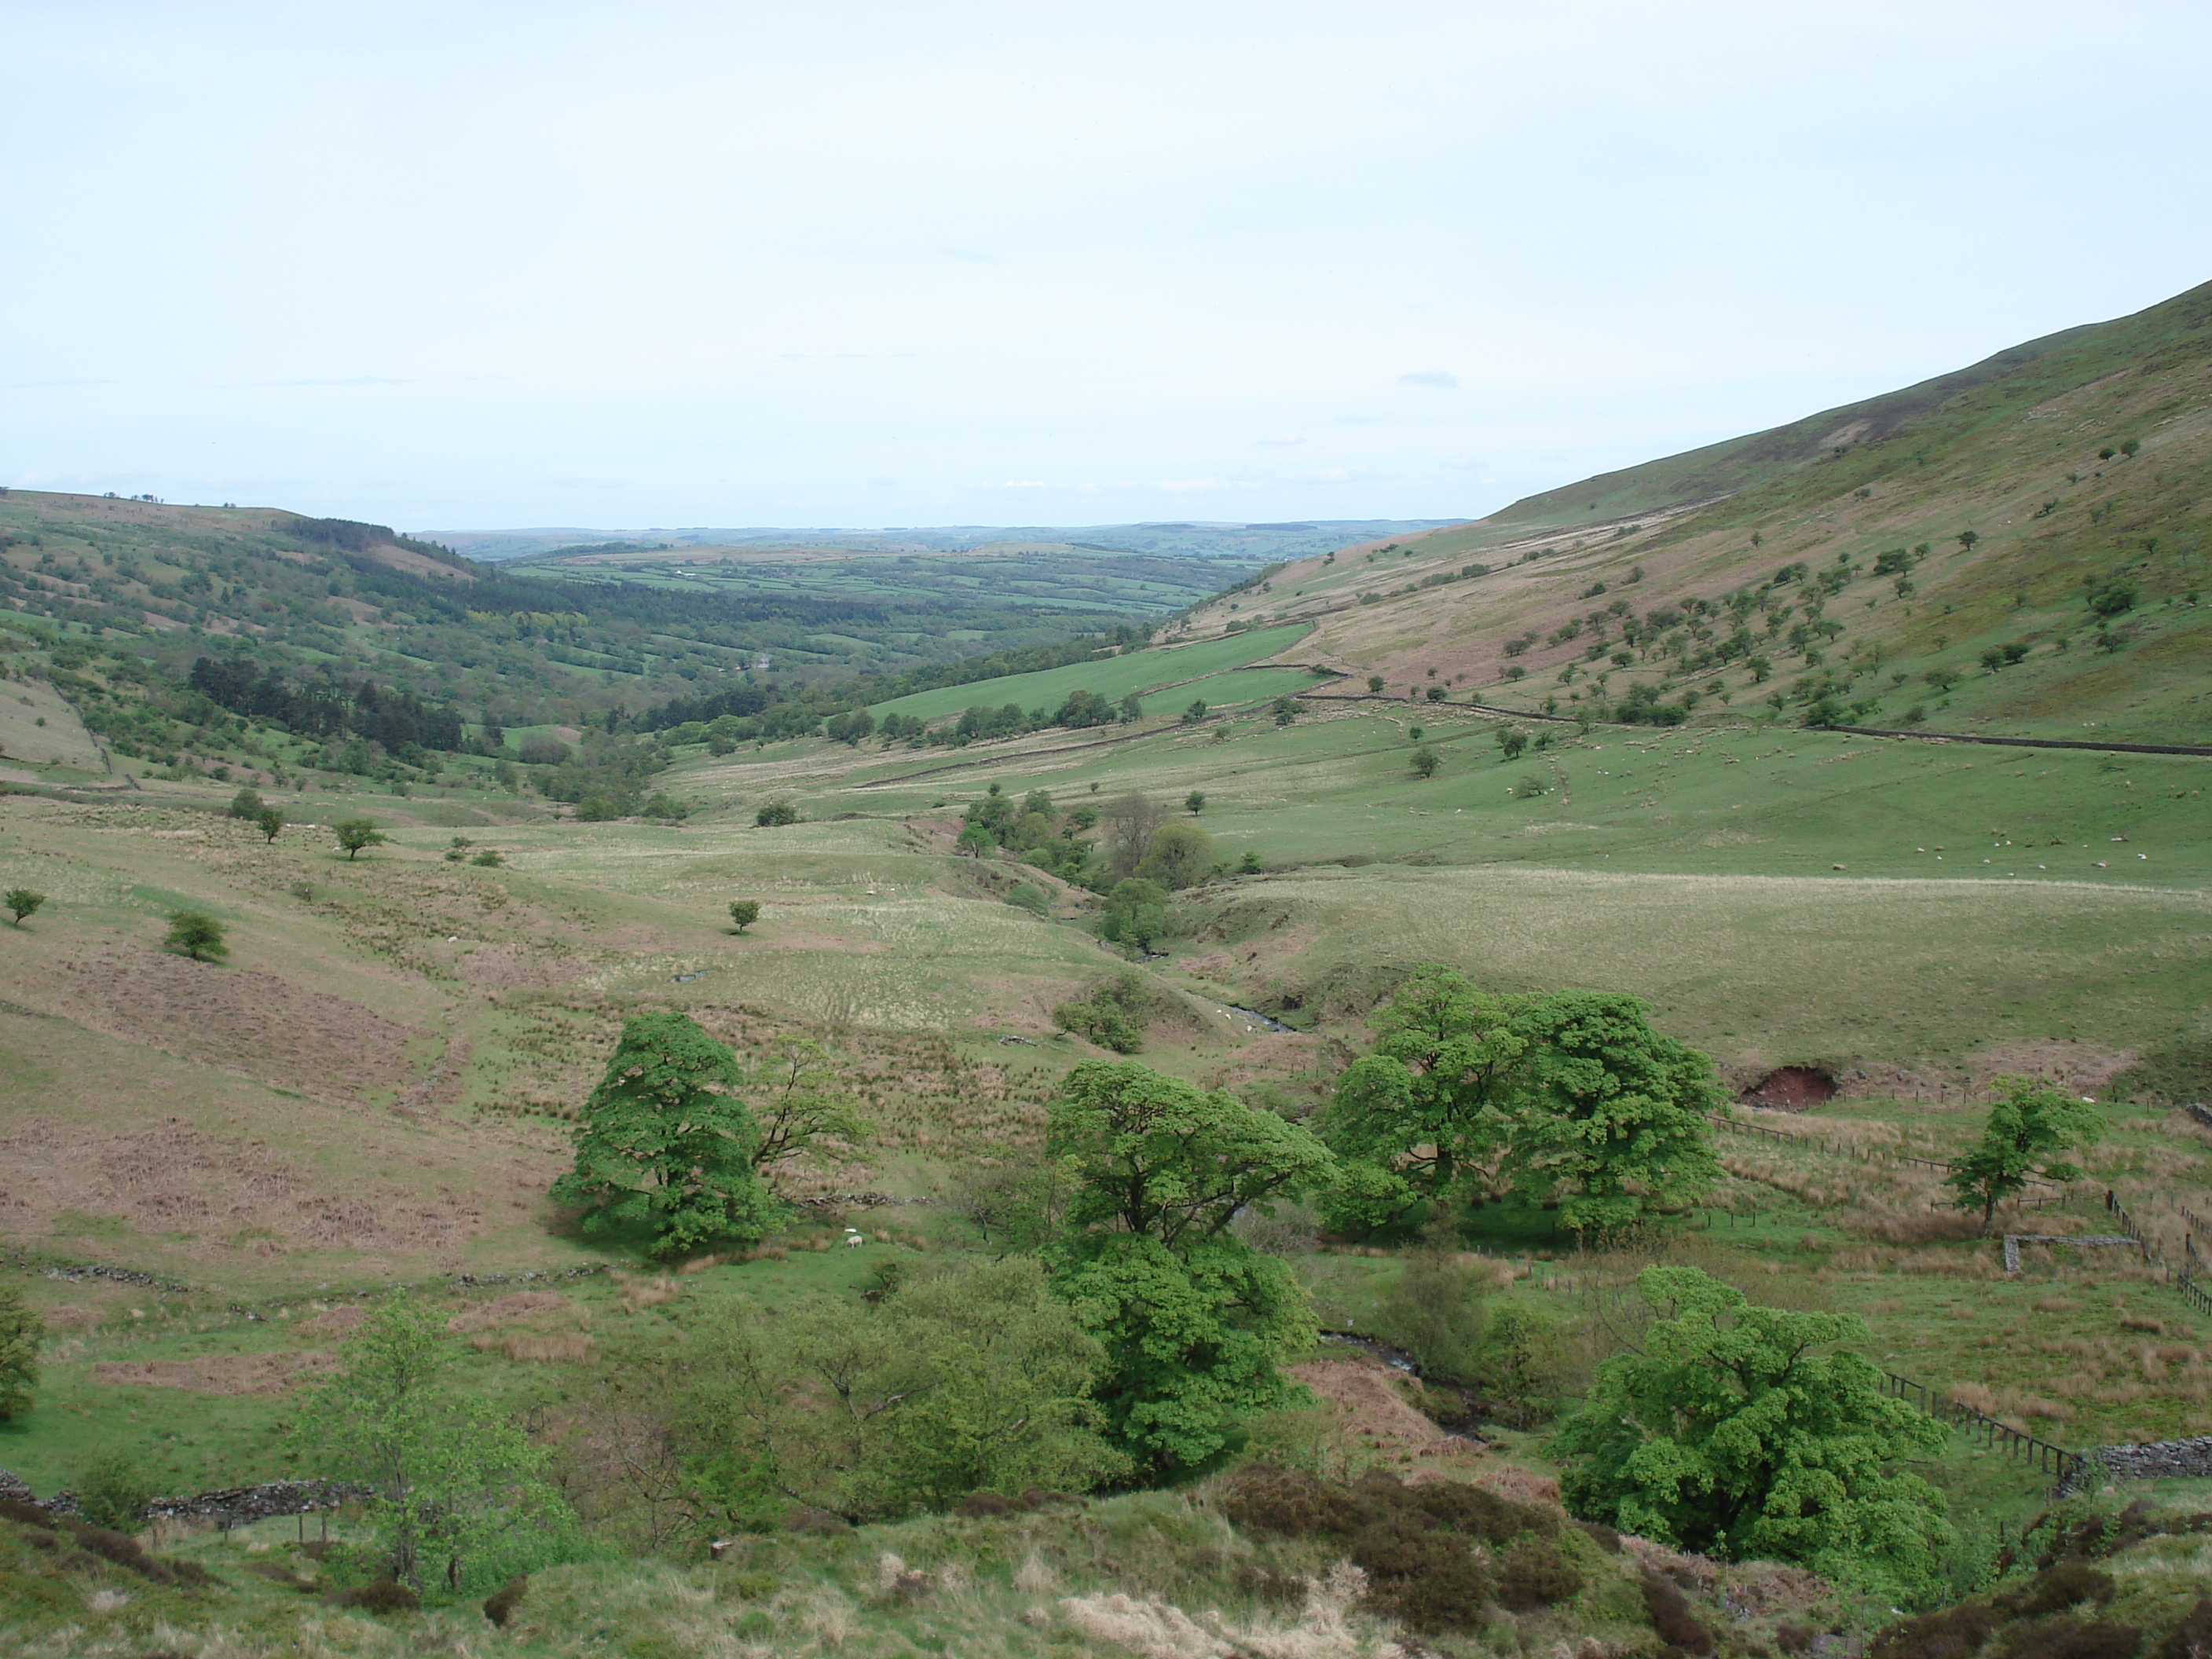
<box><xmin>0</xmin><ymin>0</ymin><xmax>2212</xmax><ymax>531</ymax></box>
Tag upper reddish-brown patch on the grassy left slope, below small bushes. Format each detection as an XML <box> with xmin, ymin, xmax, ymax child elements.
<box><xmin>51</xmin><ymin>951</ymin><xmax>429</xmax><ymax>1104</ymax></box>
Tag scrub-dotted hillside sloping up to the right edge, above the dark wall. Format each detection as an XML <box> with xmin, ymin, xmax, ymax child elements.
<box><xmin>1181</xmin><ymin>283</ymin><xmax>2212</xmax><ymax>743</ymax></box>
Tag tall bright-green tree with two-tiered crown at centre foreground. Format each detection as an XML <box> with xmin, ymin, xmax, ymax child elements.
<box><xmin>1046</xmin><ymin>1062</ymin><xmax>1336</xmax><ymax>1469</ymax></box>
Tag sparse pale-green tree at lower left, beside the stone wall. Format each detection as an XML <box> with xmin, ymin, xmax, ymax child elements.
<box><xmin>292</xmin><ymin>1296</ymin><xmax>573</xmax><ymax>1595</ymax></box>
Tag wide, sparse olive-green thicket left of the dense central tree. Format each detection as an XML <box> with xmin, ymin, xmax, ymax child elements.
<box><xmin>672</xmin><ymin>1256</ymin><xmax>1128</xmax><ymax>1526</ymax></box>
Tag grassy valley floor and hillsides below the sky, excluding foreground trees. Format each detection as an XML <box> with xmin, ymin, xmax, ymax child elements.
<box><xmin>0</xmin><ymin>290</ymin><xmax>2212</xmax><ymax>1659</ymax></box>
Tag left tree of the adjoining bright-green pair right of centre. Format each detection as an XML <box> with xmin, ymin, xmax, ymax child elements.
<box><xmin>1320</xmin><ymin>967</ymin><xmax>1529</xmax><ymax>1225</ymax></box>
